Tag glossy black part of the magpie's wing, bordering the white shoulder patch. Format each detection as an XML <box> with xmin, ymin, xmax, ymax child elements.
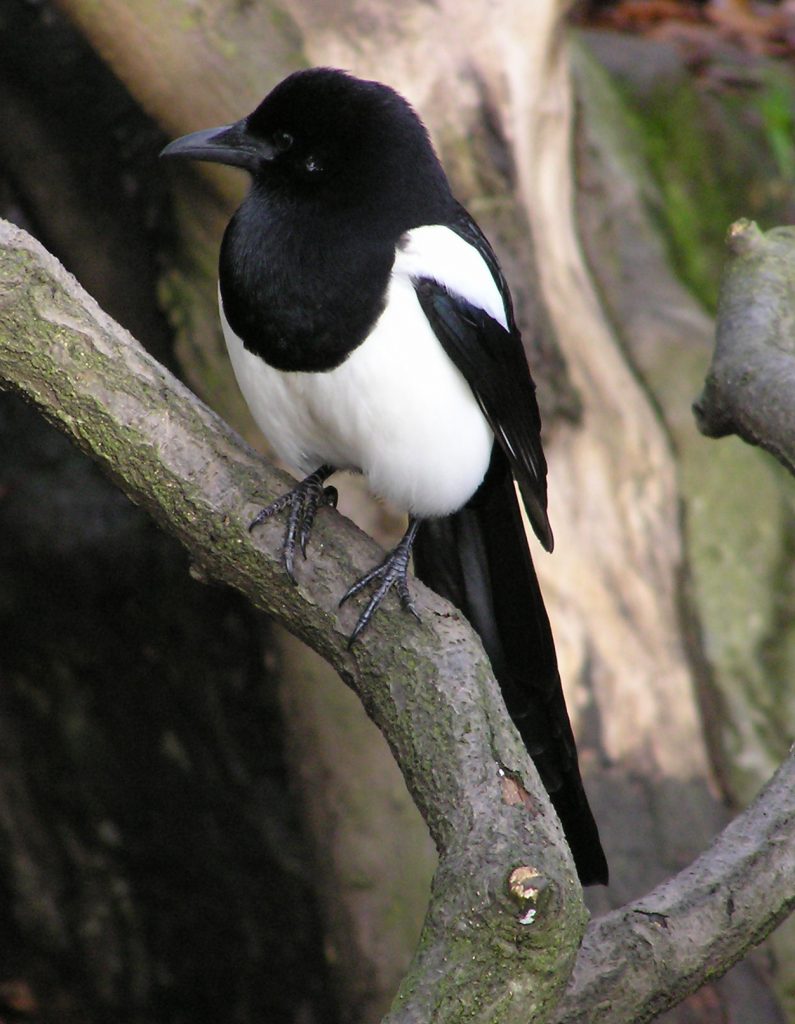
<box><xmin>414</xmin><ymin>234</ymin><xmax>553</xmax><ymax>551</ymax></box>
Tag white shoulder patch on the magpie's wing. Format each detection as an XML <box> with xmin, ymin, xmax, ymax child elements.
<box><xmin>392</xmin><ymin>224</ymin><xmax>508</xmax><ymax>330</ymax></box>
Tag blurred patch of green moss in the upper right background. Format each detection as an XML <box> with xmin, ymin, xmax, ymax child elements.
<box><xmin>621</xmin><ymin>63</ymin><xmax>795</xmax><ymax>310</ymax></box>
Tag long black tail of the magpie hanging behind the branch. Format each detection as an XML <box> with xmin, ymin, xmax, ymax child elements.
<box><xmin>414</xmin><ymin>445</ymin><xmax>608</xmax><ymax>886</ymax></box>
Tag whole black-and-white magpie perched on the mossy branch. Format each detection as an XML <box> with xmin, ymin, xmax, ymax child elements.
<box><xmin>163</xmin><ymin>68</ymin><xmax>608</xmax><ymax>885</ymax></box>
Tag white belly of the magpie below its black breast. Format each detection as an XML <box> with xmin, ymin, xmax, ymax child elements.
<box><xmin>221</xmin><ymin>275</ymin><xmax>494</xmax><ymax>516</ymax></box>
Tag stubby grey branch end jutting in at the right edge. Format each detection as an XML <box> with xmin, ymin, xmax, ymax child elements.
<box><xmin>694</xmin><ymin>220</ymin><xmax>795</xmax><ymax>472</ymax></box>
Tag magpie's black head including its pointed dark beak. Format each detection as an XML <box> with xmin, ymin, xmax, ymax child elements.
<box><xmin>163</xmin><ymin>68</ymin><xmax>452</xmax><ymax>229</ymax></box>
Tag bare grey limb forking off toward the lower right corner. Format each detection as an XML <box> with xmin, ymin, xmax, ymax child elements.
<box><xmin>555</xmin><ymin>754</ymin><xmax>795</xmax><ymax>1024</ymax></box>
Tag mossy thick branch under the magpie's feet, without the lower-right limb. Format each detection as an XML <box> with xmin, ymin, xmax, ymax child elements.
<box><xmin>0</xmin><ymin>224</ymin><xmax>584</xmax><ymax>1022</ymax></box>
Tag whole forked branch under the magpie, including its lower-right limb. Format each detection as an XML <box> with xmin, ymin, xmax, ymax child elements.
<box><xmin>0</xmin><ymin>211</ymin><xmax>795</xmax><ymax>1024</ymax></box>
